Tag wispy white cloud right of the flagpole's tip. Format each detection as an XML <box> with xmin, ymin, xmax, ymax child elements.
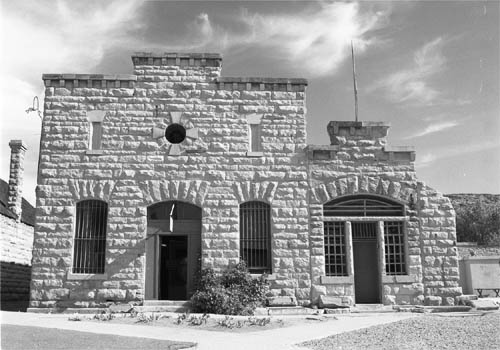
<box><xmin>368</xmin><ymin>37</ymin><xmax>446</xmax><ymax>106</ymax></box>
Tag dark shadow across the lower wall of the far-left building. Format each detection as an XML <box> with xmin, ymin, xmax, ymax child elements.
<box><xmin>0</xmin><ymin>261</ymin><xmax>31</xmax><ymax>311</ymax></box>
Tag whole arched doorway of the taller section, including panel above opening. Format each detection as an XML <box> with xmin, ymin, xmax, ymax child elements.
<box><xmin>145</xmin><ymin>201</ymin><xmax>201</xmax><ymax>300</ymax></box>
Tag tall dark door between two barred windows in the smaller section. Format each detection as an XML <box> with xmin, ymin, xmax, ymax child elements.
<box><xmin>352</xmin><ymin>222</ymin><xmax>380</xmax><ymax>304</ymax></box>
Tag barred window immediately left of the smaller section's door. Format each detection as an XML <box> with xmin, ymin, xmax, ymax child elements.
<box><xmin>324</xmin><ymin>221</ymin><xmax>347</xmax><ymax>276</ymax></box>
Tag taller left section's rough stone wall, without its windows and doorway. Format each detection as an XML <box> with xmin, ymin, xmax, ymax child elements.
<box><xmin>31</xmin><ymin>53</ymin><xmax>310</xmax><ymax>307</ymax></box>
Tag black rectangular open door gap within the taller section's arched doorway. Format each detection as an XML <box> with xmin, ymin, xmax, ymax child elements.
<box><xmin>159</xmin><ymin>236</ymin><xmax>188</xmax><ymax>300</ymax></box>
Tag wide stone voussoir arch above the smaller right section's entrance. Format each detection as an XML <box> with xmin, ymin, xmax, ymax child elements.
<box><xmin>311</xmin><ymin>175</ymin><xmax>416</xmax><ymax>204</ymax></box>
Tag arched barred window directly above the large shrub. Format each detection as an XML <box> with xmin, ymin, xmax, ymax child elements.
<box><xmin>240</xmin><ymin>201</ymin><xmax>271</xmax><ymax>273</ymax></box>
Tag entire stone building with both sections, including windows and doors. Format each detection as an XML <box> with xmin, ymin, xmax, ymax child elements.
<box><xmin>31</xmin><ymin>53</ymin><xmax>461</xmax><ymax>308</ymax></box>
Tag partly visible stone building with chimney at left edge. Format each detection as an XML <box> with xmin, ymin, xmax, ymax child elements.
<box><xmin>0</xmin><ymin>140</ymin><xmax>35</xmax><ymax>310</ymax></box>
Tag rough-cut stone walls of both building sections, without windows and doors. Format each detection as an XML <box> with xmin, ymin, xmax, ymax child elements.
<box><xmin>31</xmin><ymin>54</ymin><xmax>458</xmax><ymax>307</ymax></box>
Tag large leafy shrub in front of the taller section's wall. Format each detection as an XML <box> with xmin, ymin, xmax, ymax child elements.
<box><xmin>191</xmin><ymin>262</ymin><xmax>268</xmax><ymax>315</ymax></box>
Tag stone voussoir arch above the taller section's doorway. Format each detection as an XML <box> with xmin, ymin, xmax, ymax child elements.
<box><xmin>140</xmin><ymin>180</ymin><xmax>210</xmax><ymax>207</ymax></box>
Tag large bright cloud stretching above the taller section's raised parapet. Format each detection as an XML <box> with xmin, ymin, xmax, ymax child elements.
<box><xmin>156</xmin><ymin>3</ymin><xmax>389</xmax><ymax>76</ymax></box>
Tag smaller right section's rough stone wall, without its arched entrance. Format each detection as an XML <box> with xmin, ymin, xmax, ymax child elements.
<box><xmin>308</xmin><ymin>122</ymin><xmax>459</xmax><ymax>304</ymax></box>
